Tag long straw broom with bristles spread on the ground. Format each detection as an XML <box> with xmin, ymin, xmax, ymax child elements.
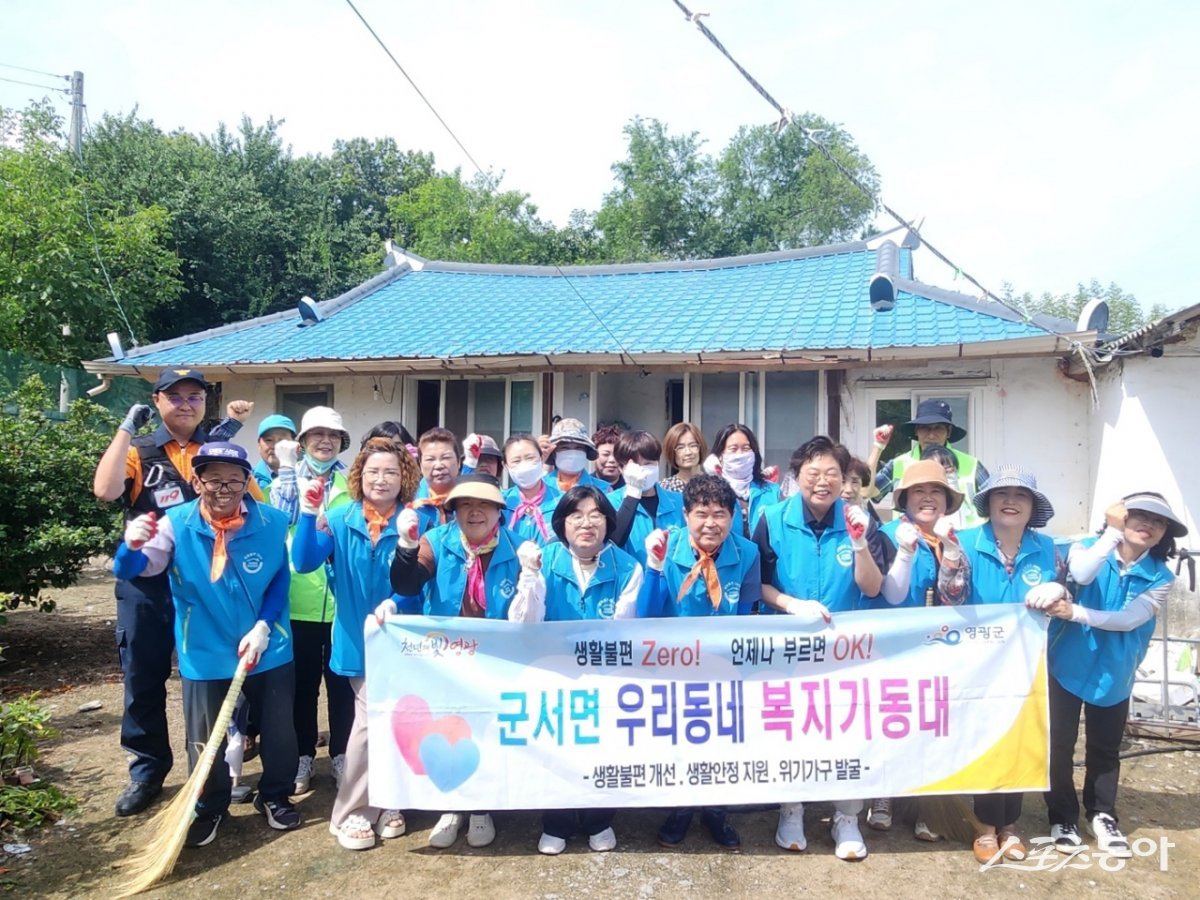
<box><xmin>118</xmin><ymin>654</ymin><xmax>250</xmax><ymax>898</ymax></box>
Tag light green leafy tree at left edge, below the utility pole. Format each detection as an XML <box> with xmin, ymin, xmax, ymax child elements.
<box><xmin>0</xmin><ymin>107</ymin><xmax>180</xmax><ymax>365</ymax></box>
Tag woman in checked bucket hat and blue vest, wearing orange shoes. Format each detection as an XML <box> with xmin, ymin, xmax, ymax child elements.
<box><xmin>935</xmin><ymin>466</ymin><xmax>1066</xmax><ymax>864</ymax></box>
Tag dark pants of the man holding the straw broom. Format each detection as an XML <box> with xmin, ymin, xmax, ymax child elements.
<box><xmin>182</xmin><ymin>662</ymin><xmax>298</xmax><ymax>816</ymax></box>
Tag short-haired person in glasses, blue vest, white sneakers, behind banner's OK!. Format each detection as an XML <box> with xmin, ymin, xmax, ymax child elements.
<box><xmin>754</xmin><ymin>434</ymin><xmax>888</xmax><ymax>860</ymax></box>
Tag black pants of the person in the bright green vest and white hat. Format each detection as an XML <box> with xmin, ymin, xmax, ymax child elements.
<box><xmin>292</xmin><ymin>619</ymin><xmax>354</xmax><ymax>756</ymax></box>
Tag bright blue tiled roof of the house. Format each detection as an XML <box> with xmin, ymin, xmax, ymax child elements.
<box><xmin>108</xmin><ymin>244</ymin><xmax>1046</xmax><ymax>367</ymax></box>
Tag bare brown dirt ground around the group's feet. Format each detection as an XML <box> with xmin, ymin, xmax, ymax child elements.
<box><xmin>0</xmin><ymin>572</ymin><xmax>1200</xmax><ymax>900</ymax></box>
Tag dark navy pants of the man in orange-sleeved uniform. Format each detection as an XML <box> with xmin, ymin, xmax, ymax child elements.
<box><xmin>116</xmin><ymin>574</ymin><xmax>175</xmax><ymax>785</ymax></box>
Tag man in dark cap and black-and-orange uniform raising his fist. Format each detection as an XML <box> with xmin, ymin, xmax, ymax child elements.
<box><xmin>92</xmin><ymin>368</ymin><xmax>262</xmax><ymax>816</ymax></box>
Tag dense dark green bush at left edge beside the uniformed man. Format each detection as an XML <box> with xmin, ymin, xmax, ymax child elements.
<box><xmin>0</xmin><ymin>376</ymin><xmax>116</xmax><ymax>608</ymax></box>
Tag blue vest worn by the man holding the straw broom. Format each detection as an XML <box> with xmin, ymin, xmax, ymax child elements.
<box><xmin>167</xmin><ymin>497</ymin><xmax>292</xmax><ymax>682</ymax></box>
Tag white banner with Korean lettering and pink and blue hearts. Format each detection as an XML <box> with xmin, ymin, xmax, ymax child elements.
<box><xmin>366</xmin><ymin>605</ymin><xmax>1049</xmax><ymax>811</ymax></box>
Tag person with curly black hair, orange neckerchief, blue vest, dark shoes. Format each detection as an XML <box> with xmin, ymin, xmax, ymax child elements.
<box><xmin>637</xmin><ymin>475</ymin><xmax>762</xmax><ymax>850</ymax></box>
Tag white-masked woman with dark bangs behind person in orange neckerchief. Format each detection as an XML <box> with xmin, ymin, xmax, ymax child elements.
<box><xmin>608</xmin><ymin>431</ymin><xmax>683</xmax><ymax>565</ymax></box>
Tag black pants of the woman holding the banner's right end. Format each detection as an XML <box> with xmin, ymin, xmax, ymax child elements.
<box><xmin>1045</xmin><ymin>677</ymin><xmax>1129</xmax><ymax>824</ymax></box>
